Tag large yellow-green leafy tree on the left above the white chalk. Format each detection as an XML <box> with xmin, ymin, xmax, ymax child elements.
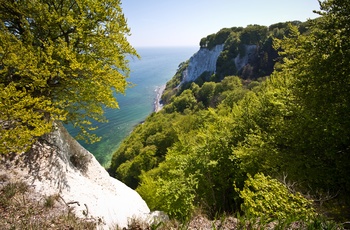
<box><xmin>0</xmin><ymin>0</ymin><xmax>137</xmax><ymax>153</ymax></box>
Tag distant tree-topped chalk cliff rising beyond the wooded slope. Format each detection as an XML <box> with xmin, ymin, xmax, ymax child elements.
<box><xmin>162</xmin><ymin>21</ymin><xmax>308</xmax><ymax>104</ymax></box>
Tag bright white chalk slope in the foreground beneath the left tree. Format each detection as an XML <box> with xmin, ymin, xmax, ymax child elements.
<box><xmin>0</xmin><ymin>122</ymin><xmax>150</xmax><ymax>229</ymax></box>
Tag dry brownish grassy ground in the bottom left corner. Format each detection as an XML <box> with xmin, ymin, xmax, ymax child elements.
<box><xmin>0</xmin><ymin>182</ymin><xmax>97</xmax><ymax>230</ymax></box>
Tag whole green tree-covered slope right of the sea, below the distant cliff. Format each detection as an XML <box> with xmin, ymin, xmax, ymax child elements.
<box><xmin>109</xmin><ymin>0</ymin><xmax>350</xmax><ymax>223</ymax></box>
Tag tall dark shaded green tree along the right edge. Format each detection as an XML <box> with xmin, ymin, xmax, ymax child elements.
<box><xmin>276</xmin><ymin>1</ymin><xmax>350</xmax><ymax>192</ymax></box>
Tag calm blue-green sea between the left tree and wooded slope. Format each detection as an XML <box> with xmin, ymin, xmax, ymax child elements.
<box><xmin>66</xmin><ymin>47</ymin><xmax>199</xmax><ymax>167</ymax></box>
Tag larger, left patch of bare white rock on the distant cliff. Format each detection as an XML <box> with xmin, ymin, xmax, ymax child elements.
<box><xmin>182</xmin><ymin>44</ymin><xmax>224</xmax><ymax>83</ymax></box>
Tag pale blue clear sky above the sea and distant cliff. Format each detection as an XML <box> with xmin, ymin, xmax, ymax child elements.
<box><xmin>122</xmin><ymin>0</ymin><xmax>319</xmax><ymax>48</ymax></box>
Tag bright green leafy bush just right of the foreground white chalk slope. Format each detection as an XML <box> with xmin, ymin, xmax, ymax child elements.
<box><xmin>136</xmin><ymin>148</ymin><xmax>197</xmax><ymax>220</ymax></box>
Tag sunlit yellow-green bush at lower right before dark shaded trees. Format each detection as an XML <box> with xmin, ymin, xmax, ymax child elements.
<box><xmin>239</xmin><ymin>174</ymin><xmax>315</xmax><ymax>221</ymax></box>
